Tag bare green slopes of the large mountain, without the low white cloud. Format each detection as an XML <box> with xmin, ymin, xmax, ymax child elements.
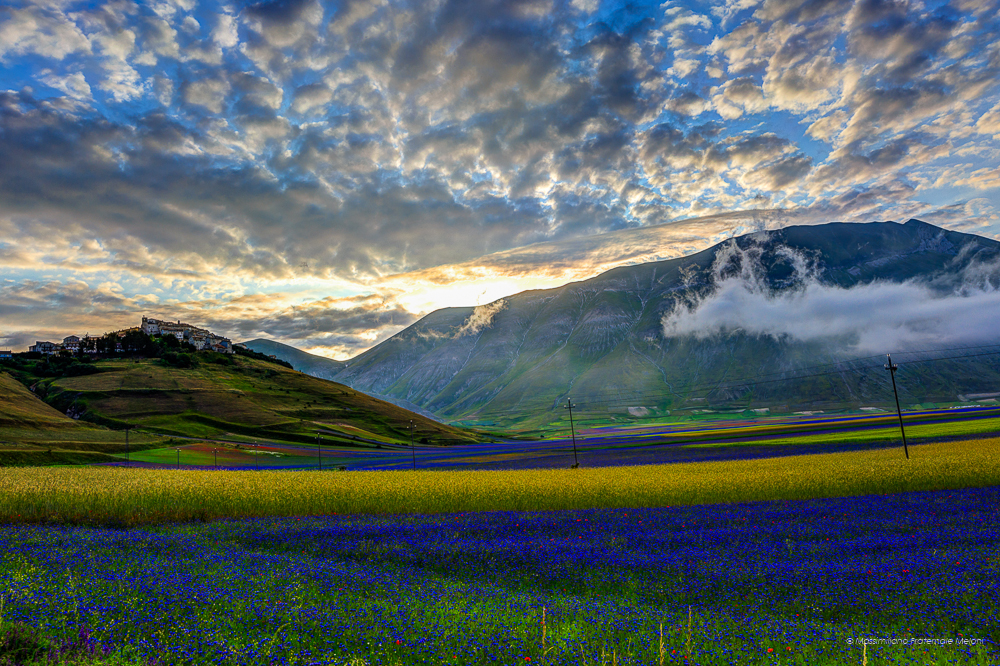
<box><xmin>278</xmin><ymin>220</ymin><xmax>1000</xmax><ymax>425</ymax></box>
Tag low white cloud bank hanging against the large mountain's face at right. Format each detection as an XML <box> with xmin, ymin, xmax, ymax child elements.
<box><xmin>662</xmin><ymin>239</ymin><xmax>1000</xmax><ymax>354</ymax></box>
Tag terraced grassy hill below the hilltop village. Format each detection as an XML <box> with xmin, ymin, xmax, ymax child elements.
<box><xmin>13</xmin><ymin>354</ymin><xmax>477</xmax><ymax>445</ymax></box>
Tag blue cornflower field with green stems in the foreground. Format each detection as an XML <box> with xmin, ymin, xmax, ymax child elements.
<box><xmin>0</xmin><ymin>487</ymin><xmax>1000</xmax><ymax>665</ymax></box>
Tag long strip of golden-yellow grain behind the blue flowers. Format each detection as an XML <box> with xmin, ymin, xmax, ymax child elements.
<box><xmin>0</xmin><ymin>438</ymin><xmax>1000</xmax><ymax>525</ymax></box>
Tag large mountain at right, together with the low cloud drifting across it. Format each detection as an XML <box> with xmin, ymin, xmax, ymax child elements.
<box><xmin>252</xmin><ymin>220</ymin><xmax>1000</xmax><ymax>426</ymax></box>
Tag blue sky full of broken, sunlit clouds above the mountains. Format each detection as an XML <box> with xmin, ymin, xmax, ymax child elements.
<box><xmin>0</xmin><ymin>0</ymin><xmax>1000</xmax><ymax>359</ymax></box>
